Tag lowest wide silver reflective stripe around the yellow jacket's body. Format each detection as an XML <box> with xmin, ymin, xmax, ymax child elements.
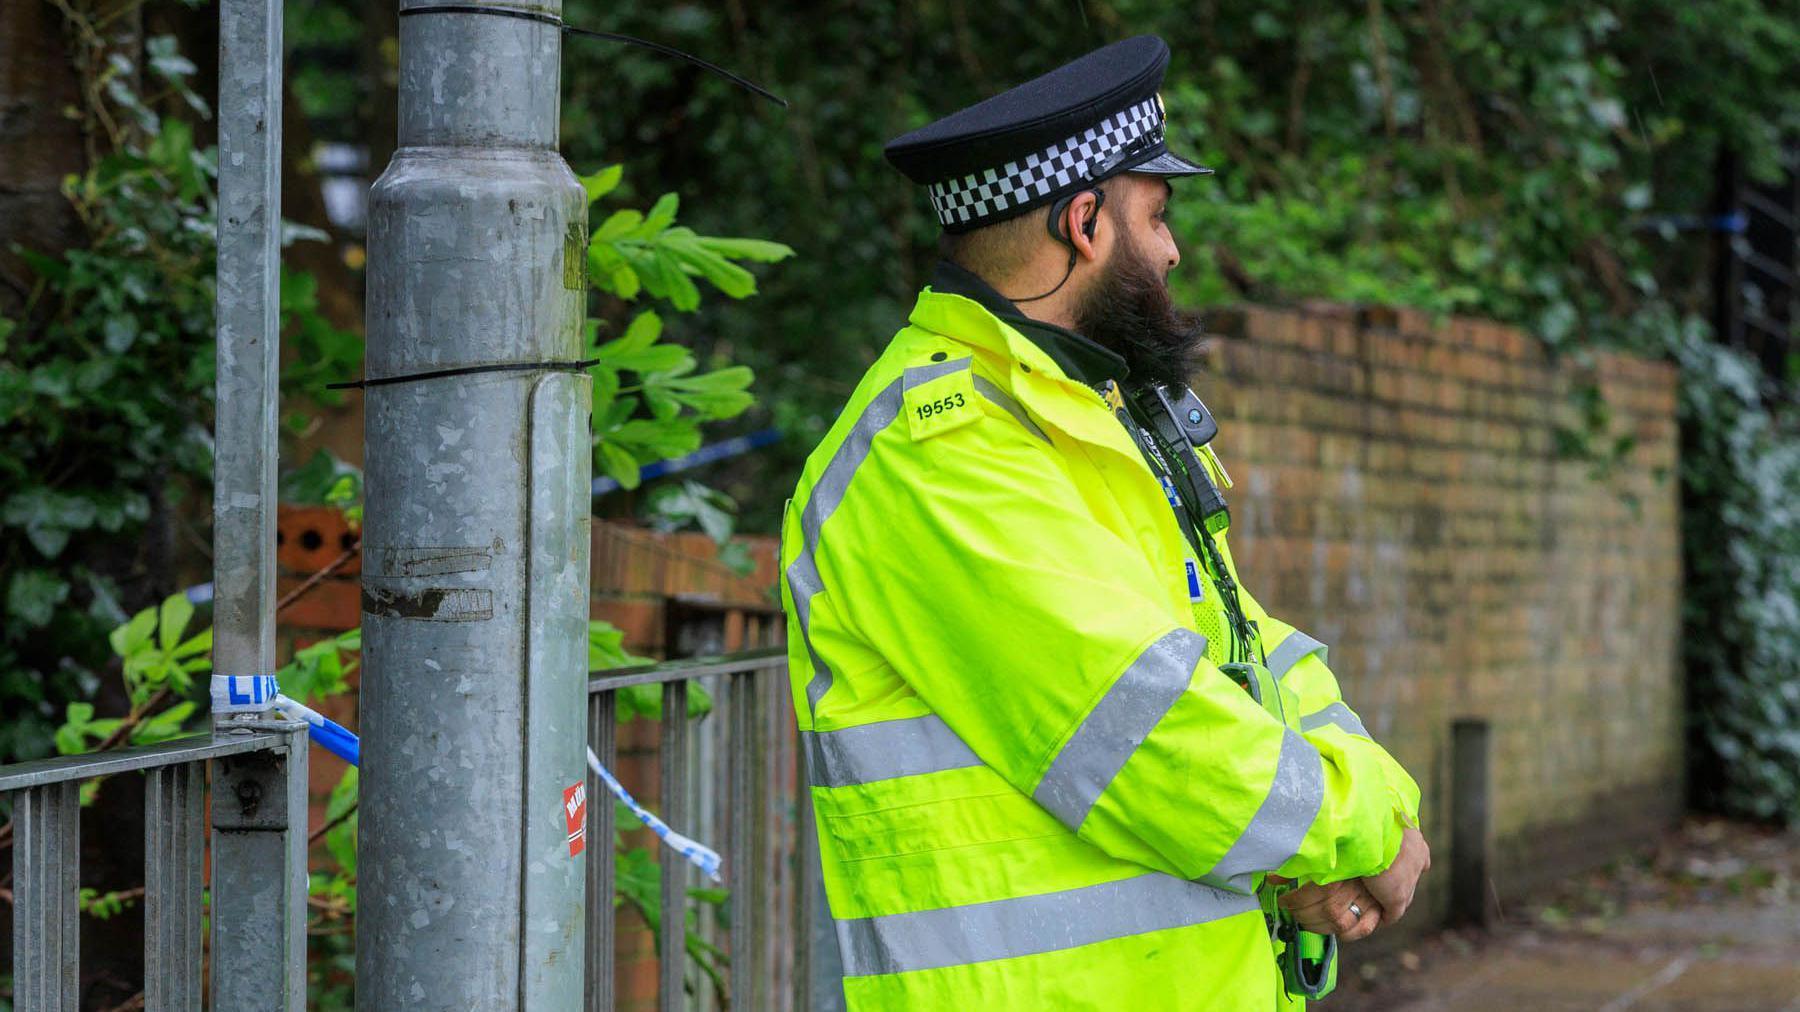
<box><xmin>837</xmin><ymin>873</ymin><xmax>1260</xmax><ymax>972</ymax></box>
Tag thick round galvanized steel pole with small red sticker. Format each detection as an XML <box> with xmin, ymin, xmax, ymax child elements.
<box><xmin>356</xmin><ymin>0</ymin><xmax>590</xmax><ymax>1010</ymax></box>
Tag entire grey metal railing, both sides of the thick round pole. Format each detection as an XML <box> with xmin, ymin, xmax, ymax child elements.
<box><xmin>0</xmin><ymin>636</ymin><xmax>835</xmax><ymax>1010</ymax></box>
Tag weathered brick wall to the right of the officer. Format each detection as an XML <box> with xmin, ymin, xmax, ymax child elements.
<box><xmin>1199</xmin><ymin>297</ymin><xmax>1681</xmax><ymax>920</ymax></box>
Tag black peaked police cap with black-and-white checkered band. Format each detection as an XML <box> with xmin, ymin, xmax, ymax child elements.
<box><xmin>884</xmin><ymin>36</ymin><xmax>1211</xmax><ymax>232</ymax></box>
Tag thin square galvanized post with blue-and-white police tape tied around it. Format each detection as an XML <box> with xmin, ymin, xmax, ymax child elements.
<box><xmin>210</xmin><ymin>0</ymin><xmax>306</xmax><ymax>1012</ymax></box>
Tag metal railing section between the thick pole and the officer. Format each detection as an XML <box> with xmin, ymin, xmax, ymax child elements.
<box><xmin>587</xmin><ymin>646</ymin><xmax>835</xmax><ymax>1010</ymax></box>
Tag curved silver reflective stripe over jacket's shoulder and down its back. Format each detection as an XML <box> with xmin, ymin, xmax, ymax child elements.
<box><xmin>787</xmin><ymin>358</ymin><xmax>974</xmax><ymax>711</ymax></box>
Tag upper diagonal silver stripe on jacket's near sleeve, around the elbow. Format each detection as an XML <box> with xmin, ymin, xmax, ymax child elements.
<box><xmin>1031</xmin><ymin>628</ymin><xmax>1206</xmax><ymax>830</ymax></box>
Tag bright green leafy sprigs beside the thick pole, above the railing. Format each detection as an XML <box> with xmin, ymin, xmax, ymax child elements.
<box><xmin>581</xmin><ymin>166</ymin><xmax>794</xmax><ymax>488</ymax></box>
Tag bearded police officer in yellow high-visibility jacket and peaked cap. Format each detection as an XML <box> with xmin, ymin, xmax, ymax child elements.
<box><xmin>781</xmin><ymin>36</ymin><xmax>1429</xmax><ymax>1010</ymax></box>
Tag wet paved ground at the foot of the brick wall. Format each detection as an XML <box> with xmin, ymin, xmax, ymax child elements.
<box><xmin>1319</xmin><ymin>819</ymin><xmax>1800</xmax><ymax>1012</ymax></box>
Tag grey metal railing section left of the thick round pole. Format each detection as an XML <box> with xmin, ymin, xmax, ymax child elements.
<box><xmin>0</xmin><ymin>722</ymin><xmax>306</xmax><ymax>1012</ymax></box>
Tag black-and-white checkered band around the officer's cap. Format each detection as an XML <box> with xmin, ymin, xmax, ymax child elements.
<box><xmin>925</xmin><ymin>95</ymin><xmax>1163</xmax><ymax>225</ymax></box>
